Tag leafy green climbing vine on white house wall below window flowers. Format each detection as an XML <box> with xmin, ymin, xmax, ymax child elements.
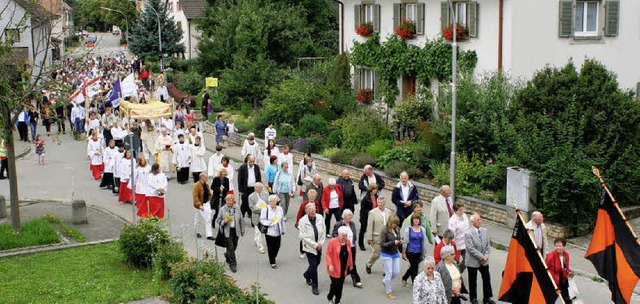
<box><xmin>351</xmin><ymin>34</ymin><xmax>478</xmax><ymax>104</ymax></box>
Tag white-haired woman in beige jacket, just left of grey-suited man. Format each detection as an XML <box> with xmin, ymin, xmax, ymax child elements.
<box><xmin>435</xmin><ymin>246</ymin><xmax>466</xmax><ymax>304</ymax></box>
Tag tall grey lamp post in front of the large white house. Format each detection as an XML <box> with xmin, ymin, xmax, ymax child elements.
<box><xmin>448</xmin><ymin>0</ymin><xmax>458</xmax><ymax>202</ymax></box>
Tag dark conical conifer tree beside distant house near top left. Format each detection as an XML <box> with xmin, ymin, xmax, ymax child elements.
<box><xmin>130</xmin><ymin>0</ymin><xmax>185</xmax><ymax>57</ymax></box>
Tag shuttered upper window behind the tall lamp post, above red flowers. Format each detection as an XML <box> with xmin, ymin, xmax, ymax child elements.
<box><xmin>440</xmin><ymin>1</ymin><xmax>478</xmax><ymax>38</ymax></box>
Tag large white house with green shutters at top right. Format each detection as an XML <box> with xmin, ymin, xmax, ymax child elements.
<box><xmin>340</xmin><ymin>0</ymin><xmax>640</xmax><ymax>100</ymax></box>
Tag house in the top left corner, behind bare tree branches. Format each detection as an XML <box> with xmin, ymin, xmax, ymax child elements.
<box><xmin>0</xmin><ymin>0</ymin><xmax>53</xmax><ymax>78</ymax></box>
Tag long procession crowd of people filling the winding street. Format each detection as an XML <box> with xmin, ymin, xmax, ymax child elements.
<box><xmin>18</xmin><ymin>52</ymin><xmax>573</xmax><ymax>304</ymax></box>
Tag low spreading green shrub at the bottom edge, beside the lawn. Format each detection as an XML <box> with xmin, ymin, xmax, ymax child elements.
<box><xmin>169</xmin><ymin>260</ymin><xmax>274</xmax><ymax>304</ymax></box>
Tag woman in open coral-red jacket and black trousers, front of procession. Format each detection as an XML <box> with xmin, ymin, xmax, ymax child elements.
<box><xmin>325</xmin><ymin>226</ymin><xmax>353</xmax><ymax>304</ymax></box>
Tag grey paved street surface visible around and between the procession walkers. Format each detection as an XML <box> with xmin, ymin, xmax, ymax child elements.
<box><xmin>0</xmin><ymin>34</ymin><xmax>640</xmax><ymax>303</ymax></box>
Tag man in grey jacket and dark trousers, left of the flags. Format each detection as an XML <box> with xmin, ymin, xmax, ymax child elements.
<box><xmin>464</xmin><ymin>213</ymin><xmax>496</xmax><ymax>304</ymax></box>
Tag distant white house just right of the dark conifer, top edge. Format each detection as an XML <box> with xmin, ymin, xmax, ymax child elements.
<box><xmin>167</xmin><ymin>0</ymin><xmax>206</xmax><ymax>59</ymax></box>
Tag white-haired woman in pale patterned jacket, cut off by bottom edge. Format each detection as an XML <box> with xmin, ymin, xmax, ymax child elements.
<box><xmin>413</xmin><ymin>256</ymin><xmax>447</xmax><ymax>304</ymax></box>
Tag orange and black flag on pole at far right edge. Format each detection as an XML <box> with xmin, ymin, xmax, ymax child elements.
<box><xmin>584</xmin><ymin>168</ymin><xmax>640</xmax><ymax>304</ymax></box>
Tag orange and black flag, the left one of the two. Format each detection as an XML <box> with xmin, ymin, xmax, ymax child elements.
<box><xmin>498</xmin><ymin>210</ymin><xmax>564</xmax><ymax>304</ymax></box>
